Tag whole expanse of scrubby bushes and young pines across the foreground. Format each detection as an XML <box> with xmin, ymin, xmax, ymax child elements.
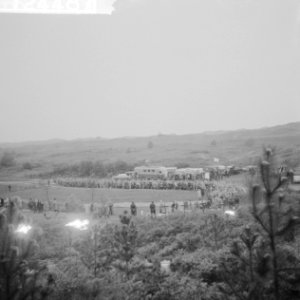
<box><xmin>0</xmin><ymin>149</ymin><xmax>300</xmax><ymax>300</ymax></box>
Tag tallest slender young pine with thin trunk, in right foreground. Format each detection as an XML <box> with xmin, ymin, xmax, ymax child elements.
<box><xmin>252</xmin><ymin>148</ymin><xmax>300</xmax><ymax>300</ymax></box>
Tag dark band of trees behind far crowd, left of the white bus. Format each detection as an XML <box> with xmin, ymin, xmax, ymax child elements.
<box><xmin>41</xmin><ymin>160</ymin><xmax>137</xmax><ymax>178</ymax></box>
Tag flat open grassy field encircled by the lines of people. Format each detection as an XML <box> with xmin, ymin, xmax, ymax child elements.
<box><xmin>2</xmin><ymin>186</ymin><xmax>207</xmax><ymax>216</ymax></box>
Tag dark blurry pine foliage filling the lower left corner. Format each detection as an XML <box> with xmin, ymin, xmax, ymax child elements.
<box><xmin>0</xmin><ymin>201</ymin><xmax>54</xmax><ymax>300</ymax></box>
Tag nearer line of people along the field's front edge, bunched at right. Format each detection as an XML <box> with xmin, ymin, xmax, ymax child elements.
<box><xmin>0</xmin><ymin>181</ymin><xmax>246</xmax><ymax>218</ymax></box>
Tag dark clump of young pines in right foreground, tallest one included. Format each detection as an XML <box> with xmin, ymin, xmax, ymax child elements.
<box><xmin>223</xmin><ymin>148</ymin><xmax>300</xmax><ymax>300</ymax></box>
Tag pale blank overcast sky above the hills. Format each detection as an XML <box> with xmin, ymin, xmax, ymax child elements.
<box><xmin>0</xmin><ymin>0</ymin><xmax>300</xmax><ymax>142</ymax></box>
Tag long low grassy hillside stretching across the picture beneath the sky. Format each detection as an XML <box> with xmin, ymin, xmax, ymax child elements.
<box><xmin>0</xmin><ymin>122</ymin><xmax>300</xmax><ymax>176</ymax></box>
